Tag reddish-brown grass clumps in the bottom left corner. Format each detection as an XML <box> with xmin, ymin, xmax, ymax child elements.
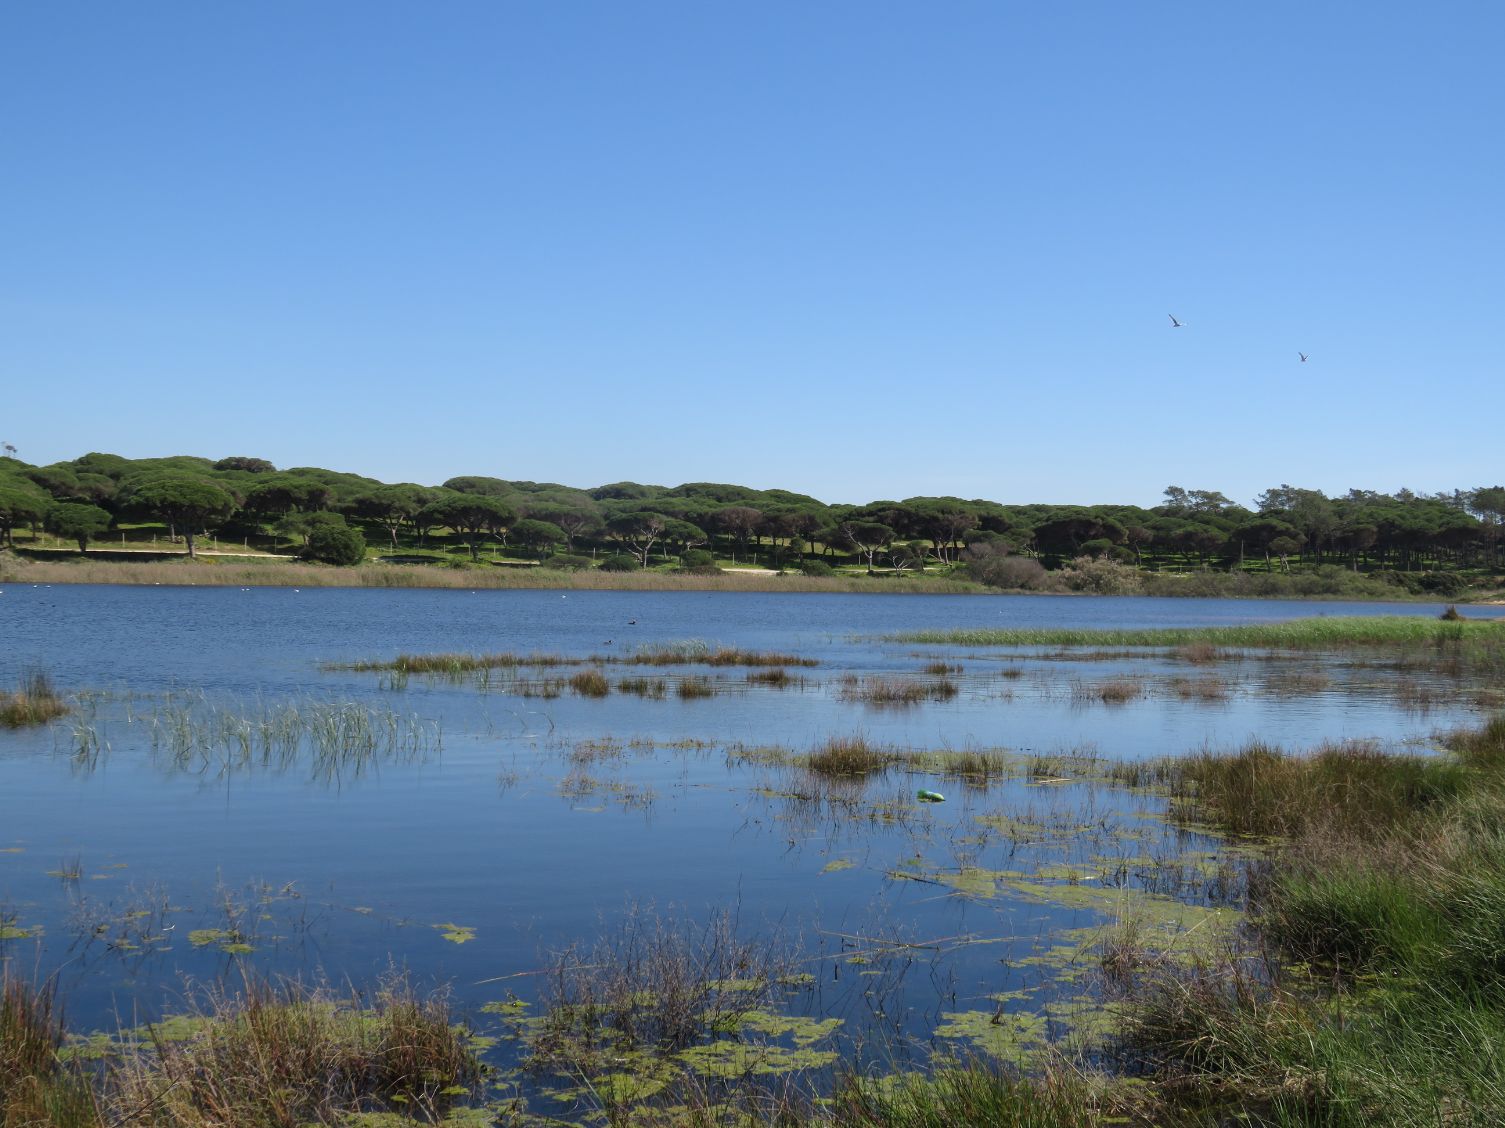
<box><xmin>0</xmin><ymin>978</ymin><xmax>482</xmax><ymax>1128</ymax></box>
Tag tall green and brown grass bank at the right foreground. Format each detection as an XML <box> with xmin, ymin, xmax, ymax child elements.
<box><xmin>1126</xmin><ymin>717</ymin><xmax>1505</xmax><ymax>1128</ymax></box>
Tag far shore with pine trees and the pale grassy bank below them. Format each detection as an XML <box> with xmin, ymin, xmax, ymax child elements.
<box><xmin>0</xmin><ymin>451</ymin><xmax>1505</xmax><ymax>602</ymax></box>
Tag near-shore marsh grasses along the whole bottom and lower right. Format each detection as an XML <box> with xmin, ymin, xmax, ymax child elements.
<box><xmin>17</xmin><ymin>716</ymin><xmax>1505</xmax><ymax>1128</ymax></box>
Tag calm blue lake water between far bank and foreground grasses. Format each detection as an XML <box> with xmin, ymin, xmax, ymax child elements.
<box><xmin>0</xmin><ymin>585</ymin><xmax>1497</xmax><ymax>1106</ymax></box>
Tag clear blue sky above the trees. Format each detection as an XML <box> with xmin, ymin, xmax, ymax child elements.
<box><xmin>0</xmin><ymin>0</ymin><xmax>1505</xmax><ymax>504</ymax></box>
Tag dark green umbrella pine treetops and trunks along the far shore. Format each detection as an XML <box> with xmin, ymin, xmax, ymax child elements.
<box><xmin>0</xmin><ymin>453</ymin><xmax>1505</xmax><ymax>582</ymax></box>
